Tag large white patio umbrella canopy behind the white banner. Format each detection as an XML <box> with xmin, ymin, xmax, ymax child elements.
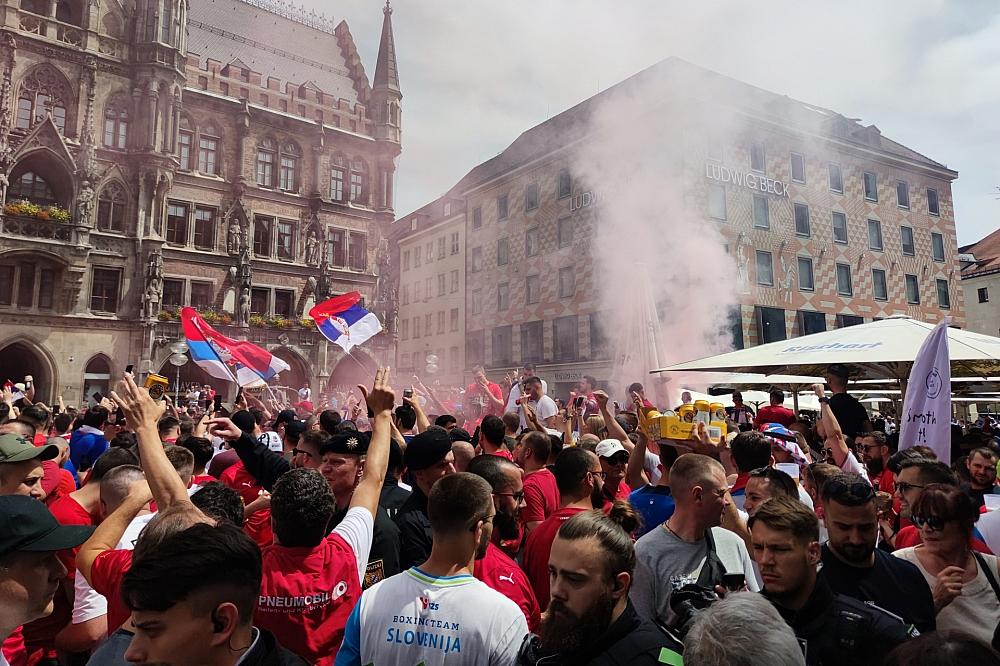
<box><xmin>652</xmin><ymin>315</ymin><xmax>1000</xmax><ymax>382</ymax></box>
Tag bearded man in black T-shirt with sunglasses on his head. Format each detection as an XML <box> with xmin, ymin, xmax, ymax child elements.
<box><xmin>821</xmin><ymin>472</ymin><xmax>935</xmax><ymax>633</ymax></box>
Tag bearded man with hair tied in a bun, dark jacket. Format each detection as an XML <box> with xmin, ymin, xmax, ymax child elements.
<box><xmin>518</xmin><ymin>502</ymin><xmax>680</xmax><ymax>666</ymax></box>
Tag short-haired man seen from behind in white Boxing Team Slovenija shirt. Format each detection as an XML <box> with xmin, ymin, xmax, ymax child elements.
<box><xmin>336</xmin><ymin>472</ymin><xmax>528</xmax><ymax>666</ymax></box>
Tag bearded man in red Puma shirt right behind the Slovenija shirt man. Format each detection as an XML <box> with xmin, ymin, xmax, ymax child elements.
<box><xmin>468</xmin><ymin>454</ymin><xmax>541</xmax><ymax>631</ymax></box>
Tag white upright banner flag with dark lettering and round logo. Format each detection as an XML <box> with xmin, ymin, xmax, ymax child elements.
<box><xmin>899</xmin><ymin>317</ymin><xmax>951</xmax><ymax>465</ymax></box>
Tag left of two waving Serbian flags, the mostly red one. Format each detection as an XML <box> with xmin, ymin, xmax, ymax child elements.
<box><xmin>181</xmin><ymin>308</ymin><xmax>290</xmax><ymax>386</ymax></box>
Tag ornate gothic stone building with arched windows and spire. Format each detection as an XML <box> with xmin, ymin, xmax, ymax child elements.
<box><xmin>0</xmin><ymin>0</ymin><xmax>401</xmax><ymax>404</ymax></box>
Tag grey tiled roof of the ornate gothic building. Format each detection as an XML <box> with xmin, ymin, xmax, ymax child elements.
<box><xmin>187</xmin><ymin>0</ymin><xmax>367</xmax><ymax>103</ymax></box>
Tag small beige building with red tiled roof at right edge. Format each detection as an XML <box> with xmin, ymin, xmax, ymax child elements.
<box><xmin>958</xmin><ymin>229</ymin><xmax>1000</xmax><ymax>336</ymax></box>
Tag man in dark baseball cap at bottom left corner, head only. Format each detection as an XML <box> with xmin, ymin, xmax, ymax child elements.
<box><xmin>0</xmin><ymin>492</ymin><xmax>94</xmax><ymax>665</ymax></box>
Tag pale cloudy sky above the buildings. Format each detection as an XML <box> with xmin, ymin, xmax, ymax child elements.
<box><xmin>324</xmin><ymin>0</ymin><xmax>1000</xmax><ymax>244</ymax></box>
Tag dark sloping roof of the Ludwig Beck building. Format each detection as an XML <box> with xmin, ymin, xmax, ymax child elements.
<box><xmin>452</xmin><ymin>57</ymin><xmax>958</xmax><ymax>192</ymax></box>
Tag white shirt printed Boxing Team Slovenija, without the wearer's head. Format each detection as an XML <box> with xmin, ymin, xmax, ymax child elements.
<box><xmin>336</xmin><ymin>567</ymin><xmax>528</xmax><ymax>666</ymax></box>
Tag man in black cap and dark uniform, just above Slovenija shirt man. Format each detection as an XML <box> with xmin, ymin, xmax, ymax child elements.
<box><xmin>395</xmin><ymin>426</ymin><xmax>455</xmax><ymax>569</ymax></box>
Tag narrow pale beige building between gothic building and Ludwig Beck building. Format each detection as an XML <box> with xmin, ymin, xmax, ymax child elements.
<box><xmin>393</xmin><ymin>197</ymin><xmax>466</xmax><ymax>386</ymax></box>
